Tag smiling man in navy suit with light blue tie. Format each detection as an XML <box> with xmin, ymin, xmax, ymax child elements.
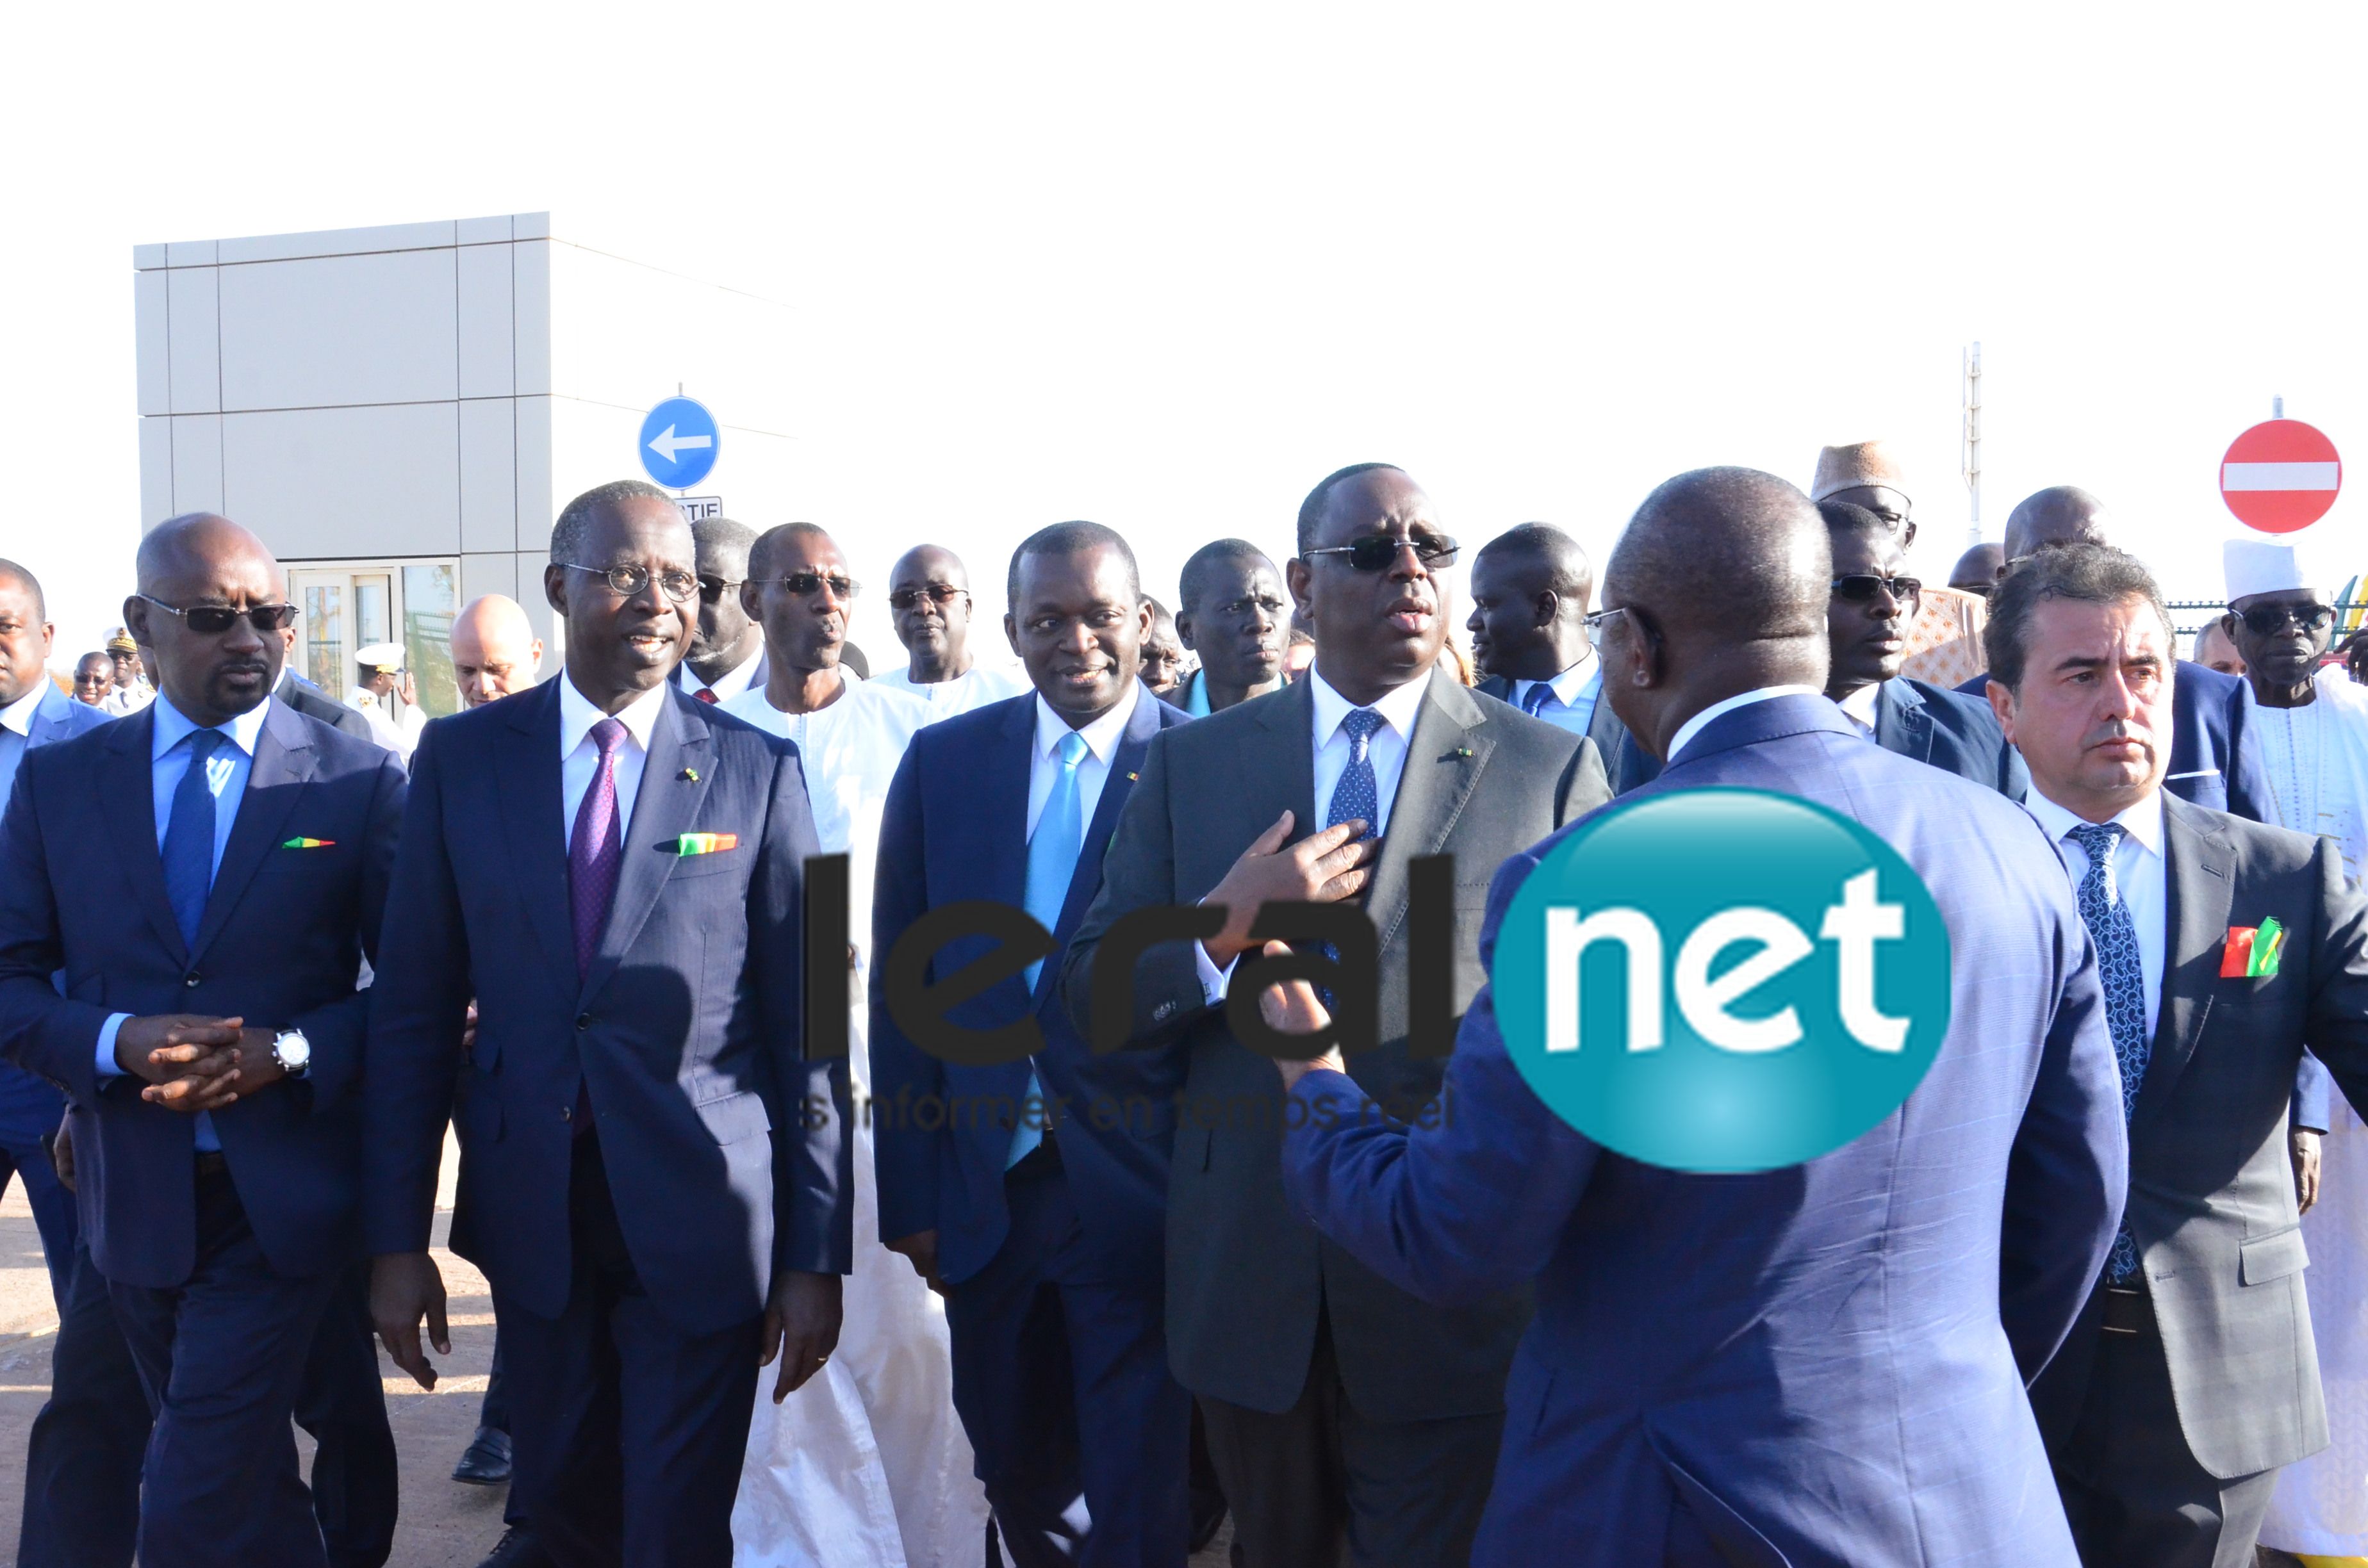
<box><xmin>871</xmin><ymin>523</ymin><xmax>1191</xmax><ymax>1568</ymax></box>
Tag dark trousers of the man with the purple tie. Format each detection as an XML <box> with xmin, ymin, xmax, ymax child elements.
<box><xmin>493</xmin><ymin>1134</ymin><xmax>762</xmax><ymax>1568</ymax></box>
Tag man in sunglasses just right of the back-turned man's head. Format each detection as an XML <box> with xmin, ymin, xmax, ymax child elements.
<box><xmin>1816</xmin><ymin>500</ymin><xmax>2032</xmax><ymax>801</ymax></box>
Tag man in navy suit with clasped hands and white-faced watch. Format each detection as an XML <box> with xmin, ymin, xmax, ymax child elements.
<box><xmin>0</xmin><ymin>514</ymin><xmax>405</xmax><ymax>1565</ymax></box>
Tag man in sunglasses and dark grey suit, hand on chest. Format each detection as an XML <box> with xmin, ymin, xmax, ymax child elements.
<box><xmin>1064</xmin><ymin>464</ymin><xmax>1610</xmax><ymax>1568</ymax></box>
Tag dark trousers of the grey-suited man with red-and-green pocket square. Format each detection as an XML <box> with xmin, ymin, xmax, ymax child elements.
<box><xmin>2051</xmin><ymin>1324</ymin><xmax>2278</xmax><ymax>1568</ymax></box>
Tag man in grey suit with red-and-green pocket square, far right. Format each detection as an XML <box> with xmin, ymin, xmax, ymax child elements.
<box><xmin>1984</xmin><ymin>545</ymin><xmax>2368</xmax><ymax>1568</ymax></box>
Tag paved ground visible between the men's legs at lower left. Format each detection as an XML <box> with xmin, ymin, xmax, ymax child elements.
<box><xmin>0</xmin><ymin>1151</ymin><xmax>1224</xmax><ymax>1568</ymax></box>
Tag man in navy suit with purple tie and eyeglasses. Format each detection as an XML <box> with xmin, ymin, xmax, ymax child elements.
<box><xmin>362</xmin><ymin>481</ymin><xmax>853</xmax><ymax>1568</ymax></box>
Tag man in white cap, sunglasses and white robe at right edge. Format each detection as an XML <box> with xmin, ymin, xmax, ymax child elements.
<box><xmin>2219</xmin><ymin>537</ymin><xmax>2368</xmax><ymax>1558</ymax></box>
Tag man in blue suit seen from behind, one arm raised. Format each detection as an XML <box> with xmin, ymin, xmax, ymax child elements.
<box><xmin>1265</xmin><ymin>469</ymin><xmax>2126</xmax><ymax>1568</ymax></box>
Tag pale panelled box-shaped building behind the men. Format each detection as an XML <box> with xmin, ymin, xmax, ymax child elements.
<box><xmin>133</xmin><ymin>213</ymin><xmax>793</xmax><ymax>713</ymax></box>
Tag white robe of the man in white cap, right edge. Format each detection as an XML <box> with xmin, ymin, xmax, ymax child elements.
<box><xmin>2245</xmin><ymin>671</ymin><xmax>2368</xmax><ymax>1556</ymax></box>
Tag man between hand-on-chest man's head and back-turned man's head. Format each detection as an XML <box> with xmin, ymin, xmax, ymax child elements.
<box><xmin>1463</xmin><ymin>523</ymin><xmax>1648</xmax><ymax>791</ymax></box>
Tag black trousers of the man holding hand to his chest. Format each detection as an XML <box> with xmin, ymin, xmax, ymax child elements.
<box><xmin>1201</xmin><ymin>1321</ymin><xmax>1504</xmax><ymax>1568</ymax></box>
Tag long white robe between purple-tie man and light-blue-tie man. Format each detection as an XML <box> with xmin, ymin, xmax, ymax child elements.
<box><xmin>722</xmin><ymin>671</ymin><xmax>987</xmax><ymax>1568</ymax></box>
